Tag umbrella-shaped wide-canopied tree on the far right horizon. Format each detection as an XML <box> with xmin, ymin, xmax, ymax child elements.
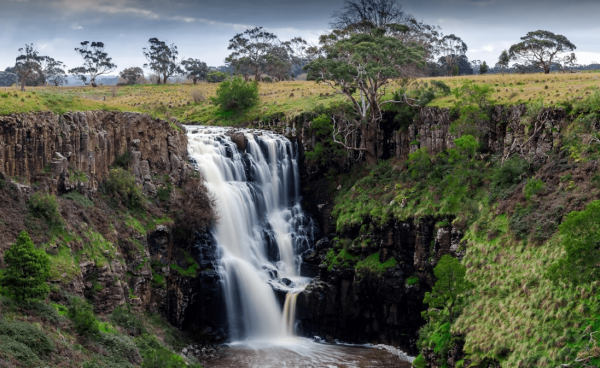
<box><xmin>508</xmin><ymin>30</ymin><xmax>577</xmax><ymax>74</ymax></box>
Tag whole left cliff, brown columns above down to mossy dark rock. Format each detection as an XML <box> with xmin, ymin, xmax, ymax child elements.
<box><xmin>0</xmin><ymin>111</ymin><xmax>222</xmax><ymax>340</ymax></box>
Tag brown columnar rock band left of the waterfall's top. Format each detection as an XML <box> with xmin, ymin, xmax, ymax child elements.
<box><xmin>0</xmin><ymin>111</ymin><xmax>187</xmax><ymax>194</ymax></box>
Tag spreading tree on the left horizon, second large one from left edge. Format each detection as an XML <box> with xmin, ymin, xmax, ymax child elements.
<box><xmin>69</xmin><ymin>41</ymin><xmax>117</xmax><ymax>87</ymax></box>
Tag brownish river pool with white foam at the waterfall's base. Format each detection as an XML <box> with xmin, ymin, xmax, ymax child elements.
<box><xmin>205</xmin><ymin>337</ymin><xmax>411</xmax><ymax>368</ymax></box>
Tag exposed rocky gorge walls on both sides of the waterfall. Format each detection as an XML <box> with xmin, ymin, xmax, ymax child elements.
<box><xmin>0</xmin><ymin>105</ymin><xmax>584</xmax><ymax>366</ymax></box>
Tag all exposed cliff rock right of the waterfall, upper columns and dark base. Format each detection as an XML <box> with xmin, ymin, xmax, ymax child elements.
<box><xmin>297</xmin><ymin>105</ymin><xmax>569</xmax><ymax>355</ymax></box>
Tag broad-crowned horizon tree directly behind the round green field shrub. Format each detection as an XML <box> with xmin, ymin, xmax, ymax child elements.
<box><xmin>225</xmin><ymin>27</ymin><xmax>279</xmax><ymax>81</ymax></box>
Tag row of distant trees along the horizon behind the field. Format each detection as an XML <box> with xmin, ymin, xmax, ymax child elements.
<box><xmin>0</xmin><ymin>0</ymin><xmax>600</xmax><ymax>90</ymax></box>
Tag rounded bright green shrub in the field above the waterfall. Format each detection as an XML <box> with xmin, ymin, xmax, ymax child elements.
<box><xmin>212</xmin><ymin>77</ymin><xmax>259</xmax><ymax>111</ymax></box>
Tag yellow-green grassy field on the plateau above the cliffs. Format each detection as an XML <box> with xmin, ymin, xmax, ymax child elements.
<box><xmin>0</xmin><ymin>72</ymin><xmax>600</xmax><ymax>125</ymax></box>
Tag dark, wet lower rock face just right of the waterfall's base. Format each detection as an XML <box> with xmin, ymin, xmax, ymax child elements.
<box><xmin>298</xmin><ymin>219</ymin><xmax>462</xmax><ymax>354</ymax></box>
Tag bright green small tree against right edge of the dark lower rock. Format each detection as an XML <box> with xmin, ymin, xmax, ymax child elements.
<box><xmin>423</xmin><ymin>255</ymin><xmax>470</xmax><ymax>323</ymax></box>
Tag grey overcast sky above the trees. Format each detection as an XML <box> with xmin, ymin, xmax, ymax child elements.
<box><xmin>0</xmin><ymin>0</ymin><xmax>600</xmax><ymax>70</ymax></box>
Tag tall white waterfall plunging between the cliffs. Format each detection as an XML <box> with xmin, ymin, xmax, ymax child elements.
<box><xmin>188</xmin><ymin>127</ymin><xmax>313</xmax><ymax>341</ymax></box>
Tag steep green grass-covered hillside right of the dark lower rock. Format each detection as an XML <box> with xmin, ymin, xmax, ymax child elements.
<box><xmin>312</xmin><ymin>90</ymin><xmax>600</xmax><ymax>367</ymax></box>
